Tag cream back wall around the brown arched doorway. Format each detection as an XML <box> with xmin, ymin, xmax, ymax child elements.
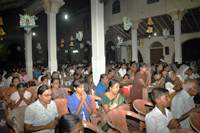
<box><xmin>126</xmin><ymin>32</ymin><xmax>200</xmax><ymax>64</ymax></box>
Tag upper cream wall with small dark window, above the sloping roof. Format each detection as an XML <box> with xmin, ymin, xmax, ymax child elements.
<box><xmin>104</xmin><ymin>0</ymin><xmax>200</xmax><ymax>26</ymax></box>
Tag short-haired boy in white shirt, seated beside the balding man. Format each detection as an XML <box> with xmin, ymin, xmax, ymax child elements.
<box><xmin>145</xmin><ymin>88</ymin><xmax>180</xmax><ymax>133</ymax></box>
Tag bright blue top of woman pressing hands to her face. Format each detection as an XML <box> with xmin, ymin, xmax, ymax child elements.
<box><xmin>67</xmin><ymin>92</ymin><xmax>92</xmax><ymax>121</ymax></box>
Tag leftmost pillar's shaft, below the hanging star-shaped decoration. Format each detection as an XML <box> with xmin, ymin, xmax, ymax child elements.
<box><xmin>24</xmin><ymin>31</ymin><xmax>33</xmax><ymax>79</ymax></box>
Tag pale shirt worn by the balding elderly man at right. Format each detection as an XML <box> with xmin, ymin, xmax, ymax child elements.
<box><xmin>171</xmin><ymin>89</ymin><xmax>195</xmax><ymax>130</ymax></box>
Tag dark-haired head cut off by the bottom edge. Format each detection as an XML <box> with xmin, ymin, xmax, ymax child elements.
<box><xmin>56</xmin><ymin>114</ymin><xmax>84</xmax><ymax>133</ymax></box>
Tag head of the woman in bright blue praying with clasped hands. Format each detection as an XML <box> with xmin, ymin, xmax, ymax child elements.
<box><xmin>72</xmin><ymin>79</ymin><xmax>84</xmax><ymax>95</ymax></box>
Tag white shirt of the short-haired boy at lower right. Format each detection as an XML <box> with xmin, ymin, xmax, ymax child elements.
<box><xmin>145</xmin><ymin>107</ymin><xmax>173</xmax><ymax>133</ymax></box>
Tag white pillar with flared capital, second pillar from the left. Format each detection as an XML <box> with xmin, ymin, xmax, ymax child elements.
<box><xmin>40</xmin><ymin>0</ymin><xmax>65</xmax><ymax>73</ymax></box>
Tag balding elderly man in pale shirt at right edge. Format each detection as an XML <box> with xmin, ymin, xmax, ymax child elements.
<box><xmin>171</xmin><ymin>79</ymin><xmax>200</xmax><ymax>130</ymax></box>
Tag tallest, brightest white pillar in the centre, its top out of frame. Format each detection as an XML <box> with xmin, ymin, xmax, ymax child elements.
<box><xmin>91</xmin><ymin>0</ymin><xmax>105</xmax><ymax>85</ymax></box>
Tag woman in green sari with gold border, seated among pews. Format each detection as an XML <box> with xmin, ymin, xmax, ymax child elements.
<box><xmin>101</xmin><ymin>79</ymin><xmax>130</xmax><ymax>133</ymax></box>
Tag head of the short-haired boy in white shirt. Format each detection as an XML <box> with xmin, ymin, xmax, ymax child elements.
<box><xmin>151</xmin><ymin>87</ymin><xmax>171</xmax><ymax>108</ymax></box>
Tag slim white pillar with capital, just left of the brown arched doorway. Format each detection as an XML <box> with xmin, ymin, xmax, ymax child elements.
<box><xmin>131</xmin><ymin>19</ymin><xmax>142</xmax><ymax>62</ymax></box>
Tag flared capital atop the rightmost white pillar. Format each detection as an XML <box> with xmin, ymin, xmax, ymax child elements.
<box><xmin>167</xmin><ymin>8</ymin><xmax>188</xmax><ymax>21</ymax></box>
